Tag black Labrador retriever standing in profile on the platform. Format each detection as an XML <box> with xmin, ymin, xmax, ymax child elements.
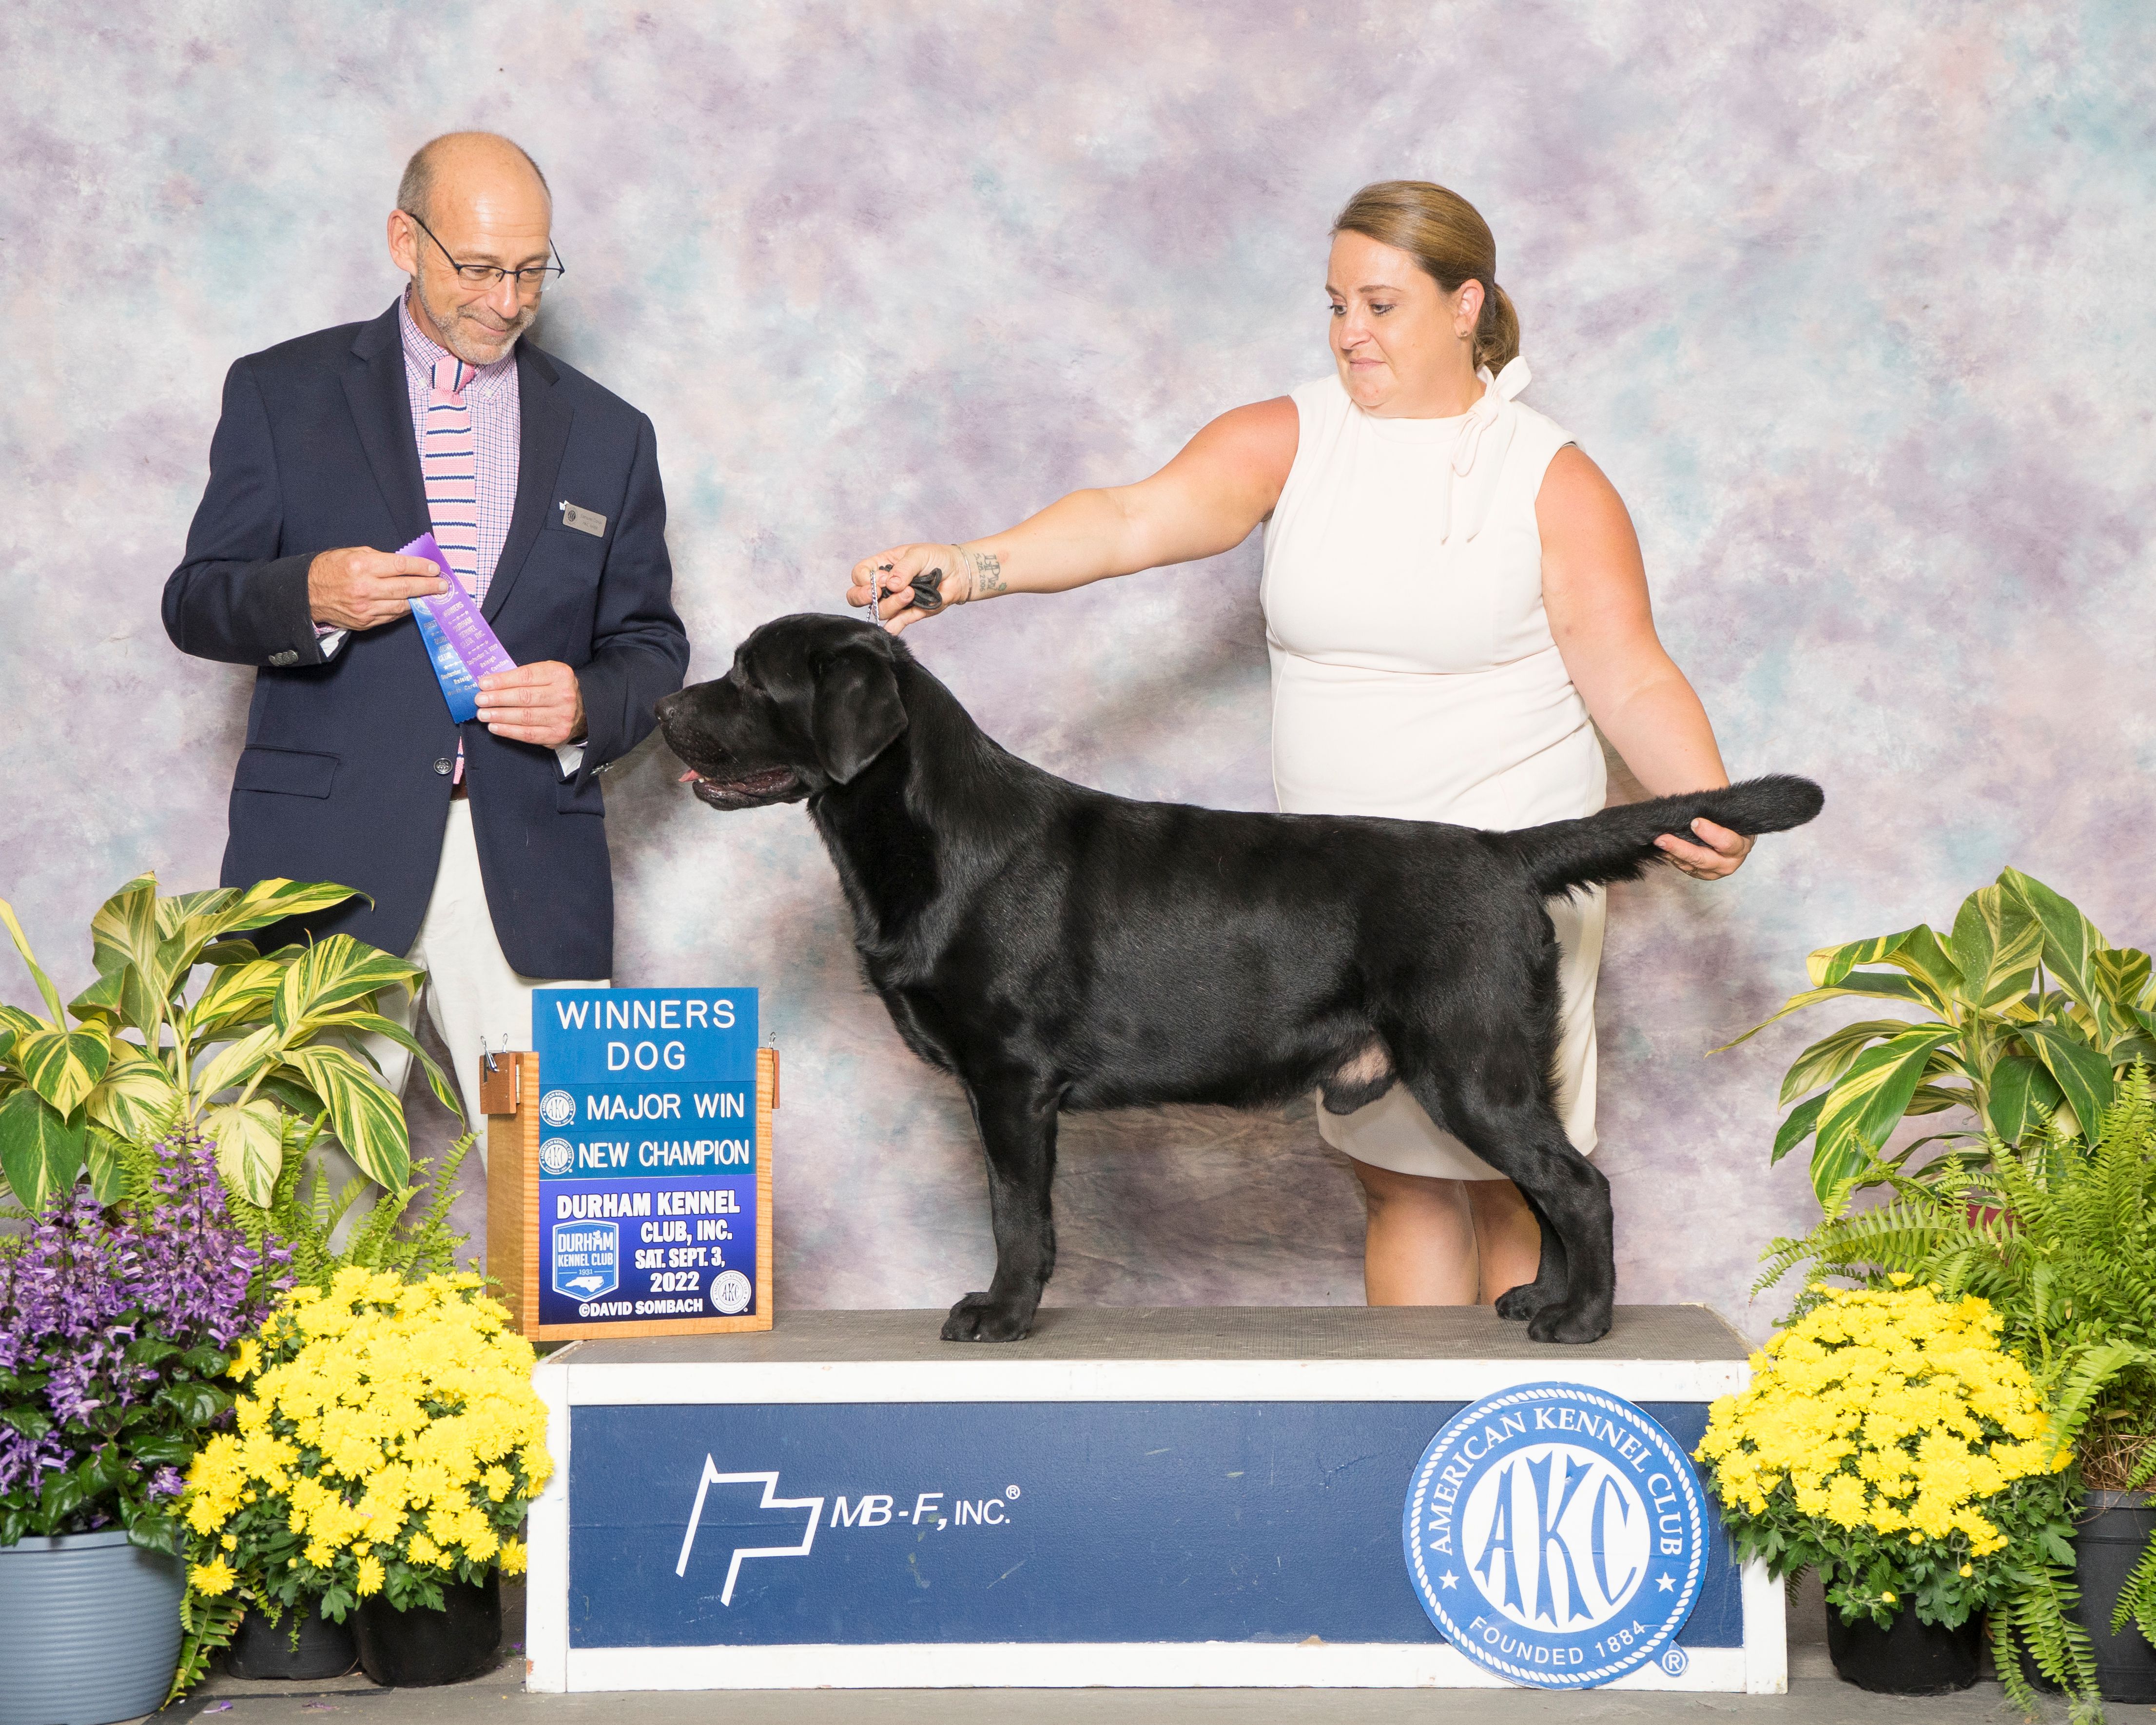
<box><xmin>658</xmin><ymin>617</ymin><xmax>1822</xmax><ymax>1341</ymax></box>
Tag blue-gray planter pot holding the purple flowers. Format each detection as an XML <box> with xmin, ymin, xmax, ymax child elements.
<box><xmin>0</xmin><ymin>1529</ymin><xmax>188</xmax><ymax>1725</ymax></box>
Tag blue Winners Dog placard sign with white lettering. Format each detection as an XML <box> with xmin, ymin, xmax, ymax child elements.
<box><xmin>532</xmin><ymin>988</ymin><xmax>768</xmax><ymax>1326</ymax></box>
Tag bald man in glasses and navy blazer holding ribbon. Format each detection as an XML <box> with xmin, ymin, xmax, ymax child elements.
<box><xmin>164</xmin><ymin>132</ymin><xmax>688</xmax><ymax>1130</ymax></box>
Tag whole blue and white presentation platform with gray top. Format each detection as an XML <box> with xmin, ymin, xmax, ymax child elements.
<box><xmin>526</xmin><ymin>1307</ymin><xmax>1787</xmax><ymax>1695</ymax></box>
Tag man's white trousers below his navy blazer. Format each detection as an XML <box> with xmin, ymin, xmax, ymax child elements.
<box><xmin>364</xmin><ymin>796</ymin><xmax>608</xmax><ymax>1167</ymax></box>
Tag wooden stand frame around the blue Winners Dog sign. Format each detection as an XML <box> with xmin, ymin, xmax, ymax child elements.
<box><xmin>481</xmin><ymin>1048</ymin><xmax>778</xmax><ymax>1341</ymax></box>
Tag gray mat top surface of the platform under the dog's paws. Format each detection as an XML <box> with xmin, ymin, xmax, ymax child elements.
<box><xmin>556</xmin><ymin>1307</ymin><xmax>1750</xmax><ymax>1376</ymax></box>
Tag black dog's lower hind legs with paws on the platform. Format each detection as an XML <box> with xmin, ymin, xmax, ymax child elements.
<box><xmin>1410</xmin><ymin>1078</ymin><xmax>1617</xmax><ymax>1341</ymax></box>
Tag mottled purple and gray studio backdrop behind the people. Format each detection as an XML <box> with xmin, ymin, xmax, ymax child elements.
<box><xmin>0</xmin><ymin>0</ymin><xmax>2156</xmax><ymax>1331</ymax></box>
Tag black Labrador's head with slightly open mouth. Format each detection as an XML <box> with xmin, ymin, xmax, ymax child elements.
<box><xmin>653</xmin><ymin>614</ymin><xmax>906</xmax><ymax>808</ymax></box>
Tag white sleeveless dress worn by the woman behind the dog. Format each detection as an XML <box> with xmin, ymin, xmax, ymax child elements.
<box><xmin>1259</xmin><ymin>360</ymin><xmax>1606</xmax><ymax>1179</ymax></box>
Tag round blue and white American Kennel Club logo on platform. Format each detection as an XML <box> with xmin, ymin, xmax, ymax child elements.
<box><xmin>1401</xmin><ymin>1384</ymin><xmax>1708</xmax><ymax>1688</ymax></box>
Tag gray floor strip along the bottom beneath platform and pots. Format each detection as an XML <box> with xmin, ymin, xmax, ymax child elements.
<box><xmin>143</xmin><ymin>1583</ymin><xmax>2078</xmax><ymax>1725</ymax></box>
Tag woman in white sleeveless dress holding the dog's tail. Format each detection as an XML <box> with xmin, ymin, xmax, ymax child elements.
<box><xmin>847</xmin><ymin>181</ymin><xmax>1750</xmax><ymax>1305</ymax></box>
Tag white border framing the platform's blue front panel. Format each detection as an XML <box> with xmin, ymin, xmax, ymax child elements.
<box><xmin>524</xmin><ymin>1343</ymin><xmax>1789</xmax><ymax>1695</ymax></box>
